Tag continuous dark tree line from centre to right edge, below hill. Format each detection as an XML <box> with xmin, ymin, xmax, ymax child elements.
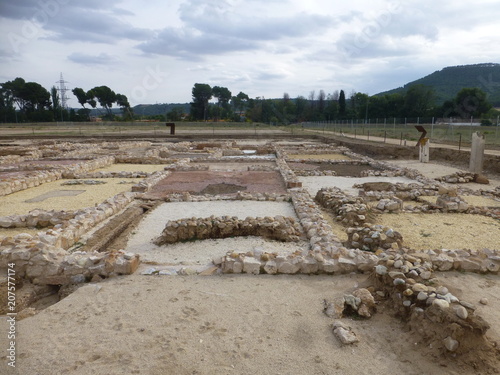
<box><xmin>190</xmin><ymin>83</ymin><xmax>499</xmax><ymax>125</ymax></box>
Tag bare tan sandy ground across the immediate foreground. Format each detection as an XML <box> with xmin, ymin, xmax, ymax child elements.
<box><xmin>0</xmin><ymin>273</ymin><xmax>500</xmax><ymax>375</ymax></box>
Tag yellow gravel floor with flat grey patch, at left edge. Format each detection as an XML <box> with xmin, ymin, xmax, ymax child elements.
<box><xmin>0</xmin><ymin>178</ymin><xmax>142</xmax><ymax>216</ymax></box>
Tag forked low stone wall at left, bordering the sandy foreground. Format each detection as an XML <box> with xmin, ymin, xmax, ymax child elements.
<box><xmin>0</xmin><ymin>193</ymin><xmax>139</xmax><ymax>285</ymax></box>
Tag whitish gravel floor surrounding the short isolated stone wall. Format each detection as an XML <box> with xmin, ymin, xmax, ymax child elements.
<box><xmin>125</xmin><ymin>201</ymin><xmax>305</xmax><ymax>265</ymax></box>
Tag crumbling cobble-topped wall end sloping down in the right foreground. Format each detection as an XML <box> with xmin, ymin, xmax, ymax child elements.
<box><xmin>374</xmin><ymin>254</ymin><xmax>490</xmax><ymax>354</ymax></box>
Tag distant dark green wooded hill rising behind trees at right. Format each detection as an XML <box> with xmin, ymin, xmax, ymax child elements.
<box><xmin>376</xmin><ymin>63</ymin><xmax>500</xmax><ymax>107</ymax></box>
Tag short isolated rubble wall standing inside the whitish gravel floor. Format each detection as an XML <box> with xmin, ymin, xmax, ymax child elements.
<box><xmin>154</xmin><ymin>216</ymin><xmax>303</xmax><ymax>246</ymax></box>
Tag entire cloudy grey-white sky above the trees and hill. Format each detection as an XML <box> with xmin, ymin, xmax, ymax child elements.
<box><xmin>0</xmin><ymin>0</ymin><xmax>500</xmax><ymax>107</ymax></box>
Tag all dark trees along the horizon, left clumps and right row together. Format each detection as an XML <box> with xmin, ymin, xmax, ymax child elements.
<box><xmin>0</xmin><ymin>77</ymin><xmax>500</xmax><ymax>125</ymax></box>
